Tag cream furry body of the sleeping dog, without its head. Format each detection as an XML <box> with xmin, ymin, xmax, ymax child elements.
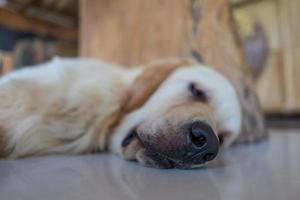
<box><xmin>0</xmin><ymin>58</ymin><xmax>138</xmax><ymax>158</ymax></box>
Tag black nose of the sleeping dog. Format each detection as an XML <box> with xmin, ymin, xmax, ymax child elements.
<box><xmin>188</xmin><ymin>121</ymin><xmax>219</xmax><ymax>164</ymax></box>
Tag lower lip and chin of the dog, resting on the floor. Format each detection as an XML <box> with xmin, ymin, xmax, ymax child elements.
<box><xmin>122</xmin><ymin>130</ymin><xmax>204</xmax><ymax>169</ymax></box>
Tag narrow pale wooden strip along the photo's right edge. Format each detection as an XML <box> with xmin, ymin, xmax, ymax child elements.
<box><xmin>279</xmin><ymin>0</ymin><xmax>300</xmax><ymax>112</ymax></box>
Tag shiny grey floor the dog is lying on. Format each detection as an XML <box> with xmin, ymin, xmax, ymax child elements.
<box><xmin>0</xmin><ymin>129</ymin><xmax>300</xmax><ymax>200</ymax></box>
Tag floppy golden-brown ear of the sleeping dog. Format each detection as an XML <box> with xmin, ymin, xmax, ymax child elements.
<box><xmin>124</xmin><ymin>59</ymin><xmax>196</xmax><ymax>112</ymax></box>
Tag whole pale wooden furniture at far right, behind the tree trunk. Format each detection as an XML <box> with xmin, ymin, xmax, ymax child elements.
<box><xmin>235</xmin><ymin>0</ymin><xmax>300</xmax><ymax>113</ymax></box>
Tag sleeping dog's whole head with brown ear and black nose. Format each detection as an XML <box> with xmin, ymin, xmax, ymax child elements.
<box><xmin>111</xmin><ymin>59</ymin><xmax>241</xmax><ymax>168</ymax></box>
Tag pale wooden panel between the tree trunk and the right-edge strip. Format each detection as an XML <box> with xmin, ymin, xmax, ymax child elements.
<box><xmin>236</xmin><ymin>1</ymin><xmax>285</xmax><ymax>112</ymax></box>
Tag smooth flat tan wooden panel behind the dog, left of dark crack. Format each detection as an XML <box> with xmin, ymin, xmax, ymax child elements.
<box><xmin>80</xmin><ymin>0</ymin><xmax>190</xmax><ymax>64</ymax></box>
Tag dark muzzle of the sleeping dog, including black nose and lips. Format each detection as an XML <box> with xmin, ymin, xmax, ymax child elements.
<box><xmin>138</xmin><ymin>121</ymin><xmax>220</xmax><ymax>168</ymax></box>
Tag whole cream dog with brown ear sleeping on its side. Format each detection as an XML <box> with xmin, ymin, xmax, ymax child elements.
<box><xmin>0</xmin><ymin>58</ymin><xmax>266</xmax><ymax>169</ymax></box>
